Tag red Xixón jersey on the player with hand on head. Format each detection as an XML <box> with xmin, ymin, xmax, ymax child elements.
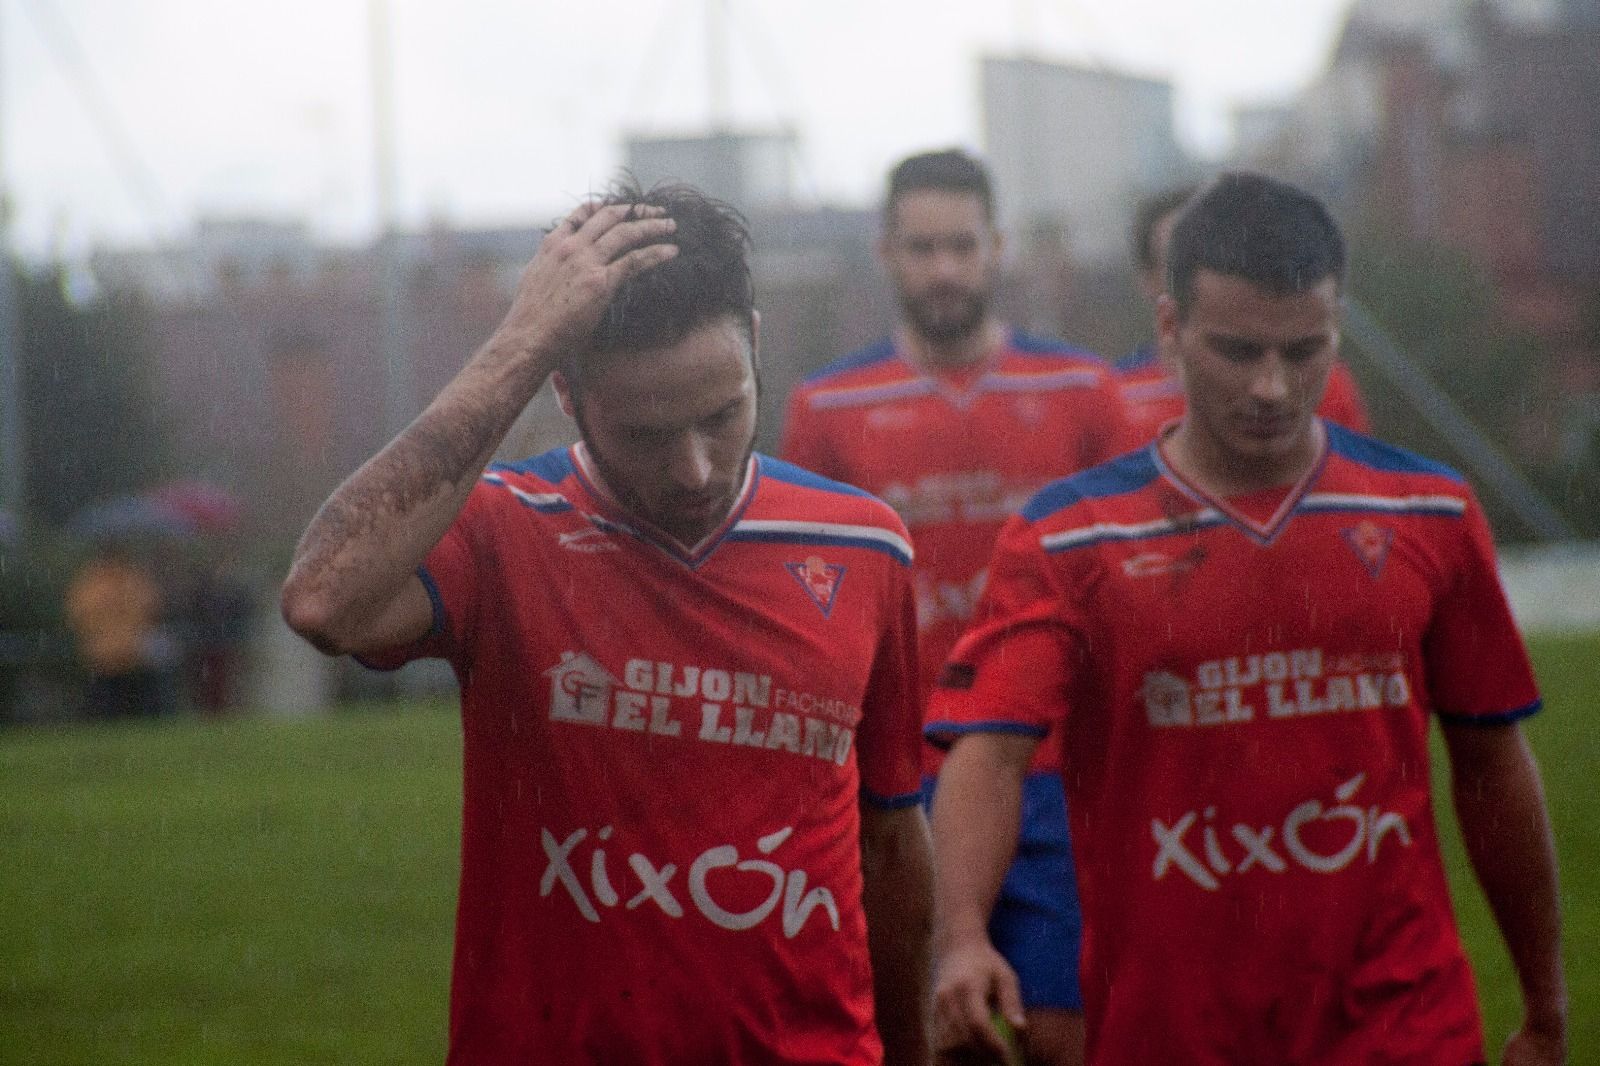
<box><xmin>366</xmin><ymin>445</ymin><xmax>920</xmax><ymax>1066</ymax></box>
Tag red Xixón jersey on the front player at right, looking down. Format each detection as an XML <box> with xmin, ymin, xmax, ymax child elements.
<box><xmin>928</xmin><ymin>426</ymin><xmax>1538</xmax><ymax>1064</ymax></box>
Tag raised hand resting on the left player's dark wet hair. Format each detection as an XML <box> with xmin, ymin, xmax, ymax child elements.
<box><xmin>501</xmin><ymin>200</ymin><xmax>678</xmax><ymax>359</ymax></box>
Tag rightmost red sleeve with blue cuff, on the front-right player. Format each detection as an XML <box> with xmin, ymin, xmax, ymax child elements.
<box><xmin>1422</xmin><ymin>498</ymin><xmax>1539</xmax><ymax>723</ymax></box>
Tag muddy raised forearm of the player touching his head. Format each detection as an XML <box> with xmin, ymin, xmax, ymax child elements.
<box><xmin>283</xmin><ymin>335</ymin><xmax>549</xmax><ymax>651</ymax></box>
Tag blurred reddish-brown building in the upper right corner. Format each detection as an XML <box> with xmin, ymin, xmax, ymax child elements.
<box><xmin>1240</xmin><ymin>0</ymin><xmax>1600</xmax><ymax>341</ymax></box>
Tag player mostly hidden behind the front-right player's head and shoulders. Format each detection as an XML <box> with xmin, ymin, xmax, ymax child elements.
<box><xmin>1115</xmin><ymin>186</ymin><xmax>1371</xmax><ymax>443</ymax></box>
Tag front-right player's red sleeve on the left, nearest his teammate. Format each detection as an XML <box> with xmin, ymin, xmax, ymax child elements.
<box><xmin>925</xmin><ymin>517</ymin><xmax>1075</xmax><ymax>747</ymax></box>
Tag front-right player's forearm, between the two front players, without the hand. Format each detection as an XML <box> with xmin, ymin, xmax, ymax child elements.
<box><xmin>933</xmin><ymin>733</ymin><xmax>1034</xmax><ymax>959</ymax></box>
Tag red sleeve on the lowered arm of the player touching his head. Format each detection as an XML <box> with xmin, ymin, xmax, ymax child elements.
<box><xmin>856</xmin><ymin>568</ymin><xmax>922</xmax><ymax>807</ymax></box>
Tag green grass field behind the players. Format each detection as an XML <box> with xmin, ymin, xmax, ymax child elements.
<box><xmin>0</xmin><ymin>637</ymin><xmax>1600</xmax><ymax>1066</ymax></box>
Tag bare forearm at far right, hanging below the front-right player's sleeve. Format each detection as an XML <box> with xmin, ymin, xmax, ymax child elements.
<box><xmin>1445</xmin><ymin>727</ymin><xmax>1566</xmax><ymax>1036</ymax></box>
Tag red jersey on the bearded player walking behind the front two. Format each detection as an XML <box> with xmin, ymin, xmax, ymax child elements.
<box><xmin>782</xmin><ymin>333</ymin><xmax>1142</xmax><ymax>713</ymax></box>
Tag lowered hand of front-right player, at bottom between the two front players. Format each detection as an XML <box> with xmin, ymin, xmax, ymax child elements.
<box><xmin>933</xmin><ymin>940</ymin><xmax>1024</xmax><ymax>1066</ymax></box>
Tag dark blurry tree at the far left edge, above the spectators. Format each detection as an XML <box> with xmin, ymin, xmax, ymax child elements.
<box><xmin>18</xmin><ymin>267</ymin><xmax>166</xmax><ymax>527</ymax></box>
